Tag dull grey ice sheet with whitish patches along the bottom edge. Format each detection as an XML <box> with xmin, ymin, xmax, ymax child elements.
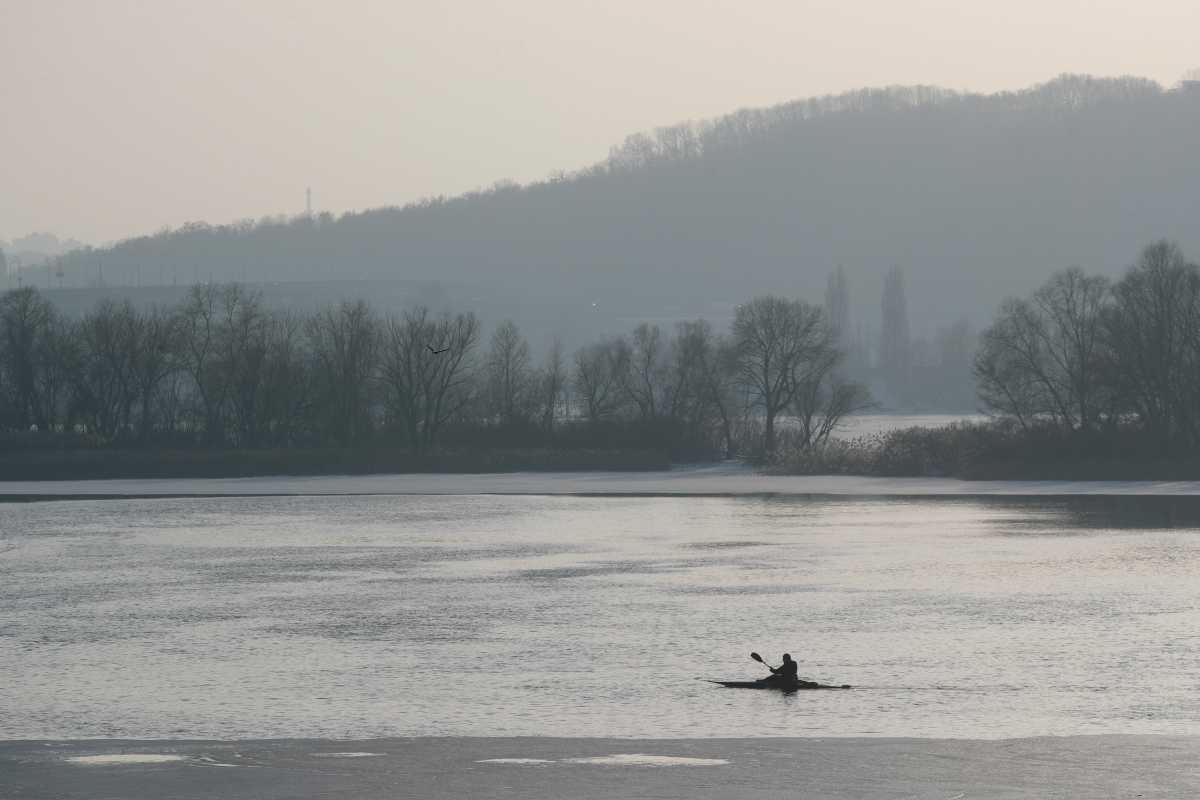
<box><xmin>0</xmin><ymin>735</ymin><xmax>1200</xmax><ymax>800</ymax></box>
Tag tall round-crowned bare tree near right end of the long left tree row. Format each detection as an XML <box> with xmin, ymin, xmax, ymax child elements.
<box><xmin>733</xmin><ymin>295</ymin><xmax>830</xmax><ymax>456</ymax></box>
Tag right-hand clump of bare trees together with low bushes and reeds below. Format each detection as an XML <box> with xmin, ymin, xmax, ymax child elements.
<box><xmin>779</xmin><ymin>241</ymin><xmax>1200</xmax><ymax>480</ymax></box>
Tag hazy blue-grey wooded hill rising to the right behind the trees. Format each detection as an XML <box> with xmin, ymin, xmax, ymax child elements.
<box><xmin>25</xmin><ymin>76</ymin><xmax>1200</xmax><ymax>347</ymax></box>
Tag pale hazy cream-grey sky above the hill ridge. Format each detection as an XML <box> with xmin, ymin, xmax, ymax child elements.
<box><xmin>0</xmin><ymin>0</ymin><xmax>1200</xmax><ymax>242</ymax></box>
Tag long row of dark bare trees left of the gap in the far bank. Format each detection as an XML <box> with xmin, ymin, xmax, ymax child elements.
<box><xmin>0</xmin><ymin>284</ymin><xmax>865</xmax><ymax>458</ymax></box>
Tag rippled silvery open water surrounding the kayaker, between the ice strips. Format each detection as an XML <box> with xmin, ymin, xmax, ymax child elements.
<box><xmin>0</xmin><ymin>497</ymin><xmax>1200</xmax><ymax>739</ymax></box>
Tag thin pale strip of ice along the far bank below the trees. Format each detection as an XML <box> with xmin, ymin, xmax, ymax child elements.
<box><xmin>0</xmin><ymin>463</ymin><xmax>1200</xmax><ymax>503</ymax></box>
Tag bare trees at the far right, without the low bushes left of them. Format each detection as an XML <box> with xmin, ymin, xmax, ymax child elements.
<box><xmin>974</xmin><ymin>241</ymin><xmax>1200</xmax><ymax>456</ymax></box>
